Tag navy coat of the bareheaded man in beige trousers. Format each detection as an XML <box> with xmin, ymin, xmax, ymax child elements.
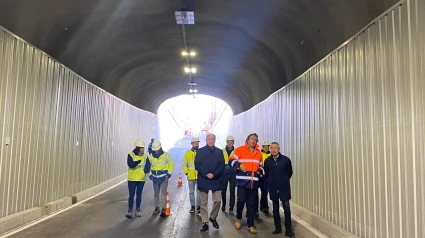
<box><xmin>195</xmin><ymin>146</ymin><xmax>224</xmax><ymax>191</ymax></box>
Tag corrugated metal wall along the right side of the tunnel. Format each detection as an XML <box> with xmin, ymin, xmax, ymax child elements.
<box><xmin>227</xmin><ymin>0</ymin><xmax>425</xmax><ymax>237</ymax></box>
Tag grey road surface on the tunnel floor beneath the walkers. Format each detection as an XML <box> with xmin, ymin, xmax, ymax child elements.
<box><xmin>4</xmin><ymin>137</ymin><xmax>317</xmax><ymax>238</ymax></box>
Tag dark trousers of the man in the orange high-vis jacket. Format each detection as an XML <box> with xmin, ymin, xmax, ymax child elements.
<box><xmin>236</xmin><ymin>187</ymin><xmax>258</xmax><ymax>227</ymax></box>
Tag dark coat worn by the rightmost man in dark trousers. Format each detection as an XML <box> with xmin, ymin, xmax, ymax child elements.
<box><xmin>264</xmin><ymin>153</ymin><xmax>292</xmax><ymax>201</ymax></box>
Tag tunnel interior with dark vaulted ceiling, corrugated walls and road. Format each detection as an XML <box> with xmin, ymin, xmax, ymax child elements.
<box><xmin>0</xmin><ymin>0</ymin><xmax>425</xmax><ymax>237</ymax></box>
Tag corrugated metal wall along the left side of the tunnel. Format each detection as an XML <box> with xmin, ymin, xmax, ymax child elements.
<box><xmin>0</xmin><ymin>28</ymin><xmax>158</xmax><ymax>217</ymax></box>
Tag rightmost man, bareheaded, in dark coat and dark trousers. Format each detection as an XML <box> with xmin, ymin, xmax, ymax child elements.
<box><xmin>264</xmin><ymin>142</ymin><xmax>295</xmax><ymax>237</ymax></box>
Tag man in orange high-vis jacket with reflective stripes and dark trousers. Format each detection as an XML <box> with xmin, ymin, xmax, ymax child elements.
<box><xmin>229</xmin><ymin>133</ymin><xmax>264</xmax><ymax>234</ymax></box>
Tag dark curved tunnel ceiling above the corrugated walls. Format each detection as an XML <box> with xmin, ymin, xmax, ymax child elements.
<box><xmin>0</xmin><ymin>0</ymin><xmax>397</xmax><ymax>114</ymax></box>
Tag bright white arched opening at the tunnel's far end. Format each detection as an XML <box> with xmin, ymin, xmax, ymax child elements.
<box><xmin>158</xmin><ymin>94</ymin><xmax>233</xmax><ymax>150</ymax></box>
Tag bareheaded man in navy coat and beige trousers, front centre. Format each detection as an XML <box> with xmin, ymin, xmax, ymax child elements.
<box><xmin>195</xmin><ymin>134</ymin><xmax>224</xmax><ymax>232</ymax></box>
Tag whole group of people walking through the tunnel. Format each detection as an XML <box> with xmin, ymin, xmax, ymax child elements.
<box><xmin>126</xmin><ymin>133</ymin><xmax>295</xmax><ymax>237</ymax></box>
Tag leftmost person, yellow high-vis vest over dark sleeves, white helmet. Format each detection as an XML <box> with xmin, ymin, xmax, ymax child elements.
<box><xmin>125</xmin><ymin>140</ymin><xmax>151</xmax><ymax>219</ymax></box>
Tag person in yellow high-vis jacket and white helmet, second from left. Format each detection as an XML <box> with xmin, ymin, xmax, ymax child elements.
<box><xmin>149</xmin><ymin>141</ymin><xmax>174</xmax><ymax>217</ymax></box>
